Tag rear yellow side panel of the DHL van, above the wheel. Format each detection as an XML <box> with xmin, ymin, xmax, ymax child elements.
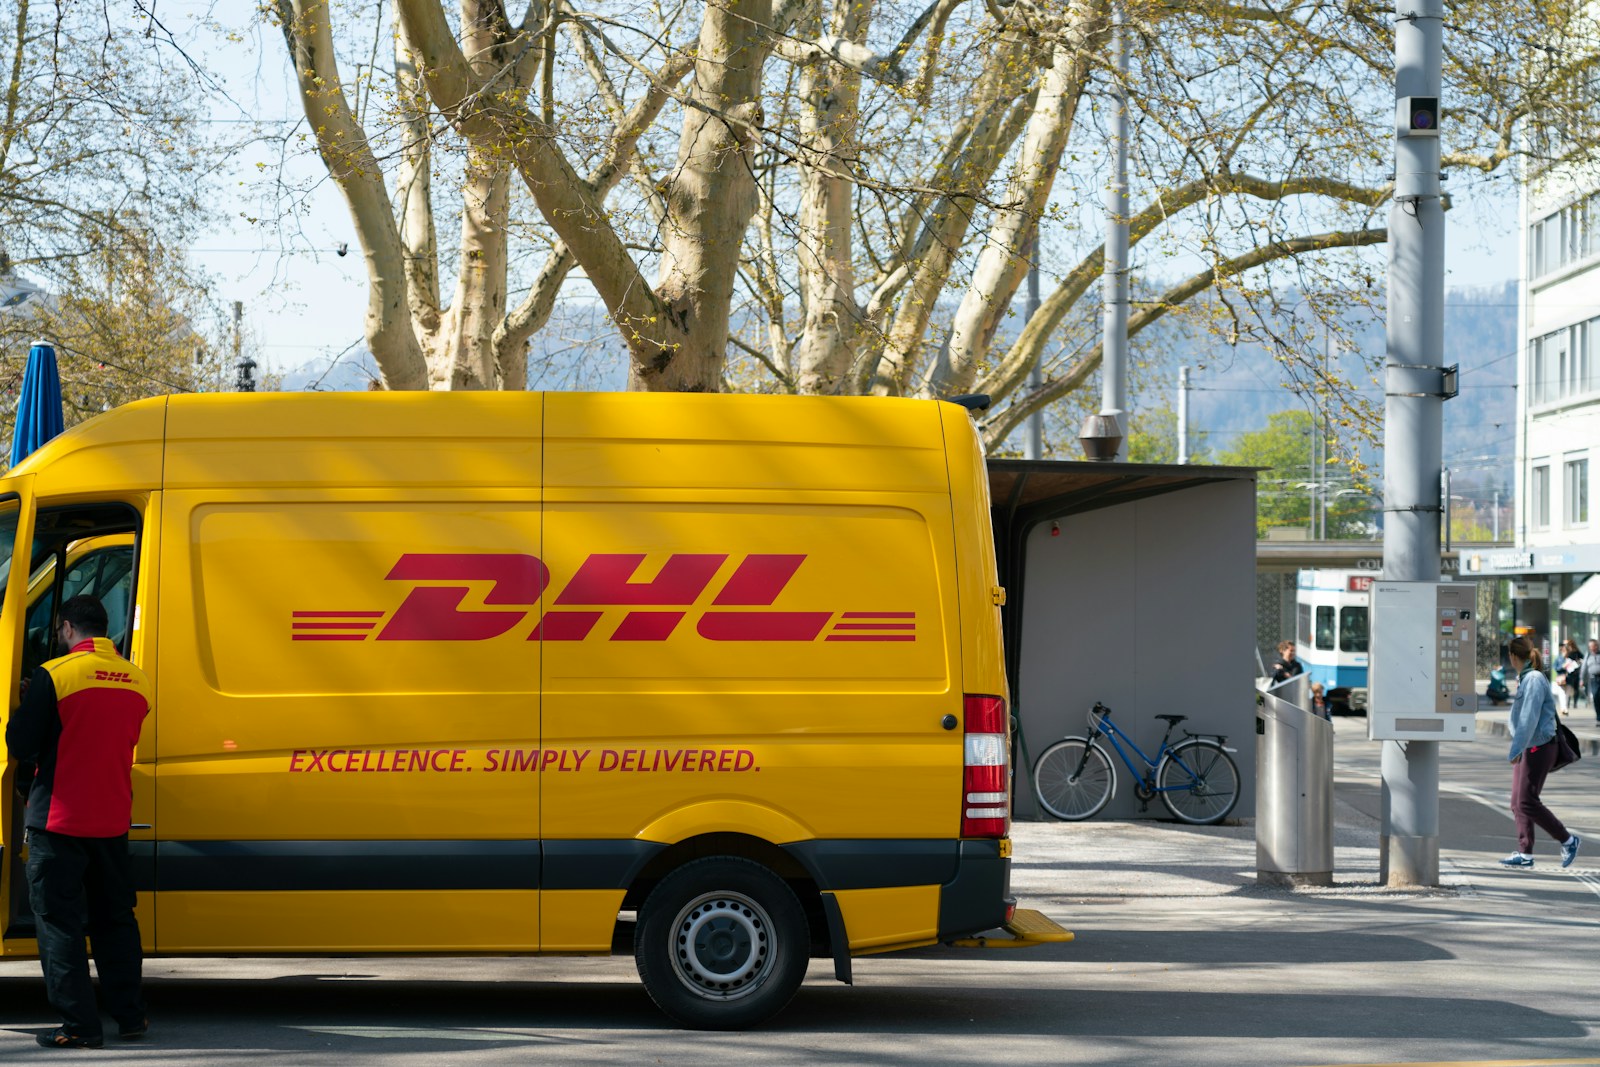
<box><xmin>541</xmin><ymin>394</ymin><xmax>962</xmax><ymax>937</ymax></box>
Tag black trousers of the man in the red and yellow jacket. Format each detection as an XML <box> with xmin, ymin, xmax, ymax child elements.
<box><xmin>27</xmin><ymin>830</ymin><xmax>146</xmax><ymax>1038</ymax></box>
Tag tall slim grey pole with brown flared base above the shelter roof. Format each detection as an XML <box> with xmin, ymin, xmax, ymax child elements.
<box><xmin>1101</xmin><ymin>5</ymin><xmax>1133</xmax><ymax>461</ymax></box>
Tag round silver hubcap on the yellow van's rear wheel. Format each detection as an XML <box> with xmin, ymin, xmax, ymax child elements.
<box><xmin>672</xmin><ymin>893</ymin><xmax>774</xmax><ymax>1000</ymax></box>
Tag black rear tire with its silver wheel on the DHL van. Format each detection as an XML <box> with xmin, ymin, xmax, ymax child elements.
<box><xmin>634</xmin><ymin>856</ymin><xmax>811</xmax><ymax>1030</ymax></box>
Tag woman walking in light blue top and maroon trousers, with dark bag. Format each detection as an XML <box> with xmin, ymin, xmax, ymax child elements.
<box><xmin>1501</xmin><ymin>637</ymin><xmax>1581</xmax><ymax>867</ymax></box>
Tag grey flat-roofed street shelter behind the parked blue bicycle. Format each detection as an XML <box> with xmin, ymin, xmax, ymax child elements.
<box><xmin>989</xmin><ymin>459</ymin><xmax>1256</xmax><ymax>819</ymax></box>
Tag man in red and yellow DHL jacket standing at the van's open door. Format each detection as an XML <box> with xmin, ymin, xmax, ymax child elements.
<box><xmin>5</xmin><ymin>597</ymin><xmax>150</xmax><ymax>1048</ymax></box>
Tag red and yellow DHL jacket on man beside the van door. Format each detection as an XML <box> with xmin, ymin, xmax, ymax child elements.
<box><xmin>5</xmin><ymin>637</ymin><xmax>150</xmax><ymax>837</ymax></box>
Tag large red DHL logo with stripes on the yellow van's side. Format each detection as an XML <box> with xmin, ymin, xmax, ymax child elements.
<box><xmin>291</xmin><ymin>552</ymin><xmax>917</xmax><ymax>641</ymax></box>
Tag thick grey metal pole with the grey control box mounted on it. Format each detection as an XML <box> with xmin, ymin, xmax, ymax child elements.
<box><xmin>1379</xmin><ymin>0</ymin><xmax>1445</xmax><ymax>886</ymax></box>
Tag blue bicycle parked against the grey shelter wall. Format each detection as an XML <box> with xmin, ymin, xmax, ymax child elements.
<box><xmin>1034</xmin><ymin>702</ymin><xmax>1240</xmax><ymax>825</ymax></box>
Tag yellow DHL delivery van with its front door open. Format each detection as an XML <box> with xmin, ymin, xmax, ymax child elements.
<box><xmin>0</xmin><ymin>394</ymin><xmax>1069</xmax><ymax>1027</ymax></box>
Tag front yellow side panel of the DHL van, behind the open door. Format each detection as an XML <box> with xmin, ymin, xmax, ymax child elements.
<box><xmin>155</xmin><ymin>395</ymin><xmax>547</xmax><ymax>953</ymax></box>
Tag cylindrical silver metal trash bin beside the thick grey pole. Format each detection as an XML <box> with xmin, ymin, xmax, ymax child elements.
<box><xmin>1256</xmin><ymin>687</ymin><xmax>1333</xmax><ymax>886</ymax></box>
